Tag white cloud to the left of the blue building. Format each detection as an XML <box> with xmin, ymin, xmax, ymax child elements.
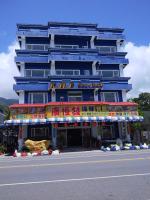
<box><xmin>0</xmin><ymin>42</ymin><xmax>19</xmax><ymax>98</ymax></box>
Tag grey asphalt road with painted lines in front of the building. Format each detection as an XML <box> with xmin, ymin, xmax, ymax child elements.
<box><xmin>0</xmin><ymin>150</ymin><xmax>150</xmax><ymax>200</ymax></box>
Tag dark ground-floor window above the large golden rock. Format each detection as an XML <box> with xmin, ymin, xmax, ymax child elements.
<box><xmin>31</xmin><ymin>127</ymin><xmax>49</xmax><ymax>138</ymax></box>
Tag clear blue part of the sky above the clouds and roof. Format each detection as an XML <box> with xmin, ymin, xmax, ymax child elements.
<box><xmin>0</xmin><ymin>0</ymin><xmax>150</xmax><ymax>52</ymax></box>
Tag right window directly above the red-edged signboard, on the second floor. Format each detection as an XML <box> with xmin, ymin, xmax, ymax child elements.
<box><xmin>101</xmin><ymin>92</ymin><xmax>118</xmax><ymax>102</ymax></box>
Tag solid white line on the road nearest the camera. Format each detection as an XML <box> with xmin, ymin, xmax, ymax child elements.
<box><xmin>0</xmin><ymin>173</ymin><xmax>150</xmax><ymax>187</ymax></box>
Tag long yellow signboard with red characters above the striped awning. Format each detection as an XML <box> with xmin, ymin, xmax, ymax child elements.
<box><xmin>11</xmin><ymin>105</ymin><xmax>138</xmax><ymax>119</ymax></box>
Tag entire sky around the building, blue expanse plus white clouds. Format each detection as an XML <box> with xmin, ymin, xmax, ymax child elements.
<box><xmin>0</xmin><ymin>0</ymin><xmax>150</xmax><ymax>98</ymax></box>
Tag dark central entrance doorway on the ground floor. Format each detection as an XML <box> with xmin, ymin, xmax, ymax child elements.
<box><xmin>67</xmin><ymin>129</ymin><xmax>82</xmax><ymax>147</ymax></box>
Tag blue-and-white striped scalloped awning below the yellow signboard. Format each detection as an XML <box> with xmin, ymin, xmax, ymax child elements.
<box><xmin>4</xmin><ymin>116</ymin><xmax>144</xmax><ymax>125</ymax></box>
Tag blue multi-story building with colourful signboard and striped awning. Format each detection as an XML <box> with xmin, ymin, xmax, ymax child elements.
<box><xmin>6</xmin><ymin>22</ymin><xmax>142</xmax><ymax>147</ymax></box>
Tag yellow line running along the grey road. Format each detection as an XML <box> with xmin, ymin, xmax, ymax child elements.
<box><xmin>0</xmin><ymin>157</ymin><xmax>150</xmax><ymax>169</ymax></box>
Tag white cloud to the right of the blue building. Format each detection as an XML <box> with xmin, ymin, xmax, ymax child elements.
<box><xmin>124</xmin><ymin>42</ymin><xmax>150</xmax><ymax>97</ymax></box>
